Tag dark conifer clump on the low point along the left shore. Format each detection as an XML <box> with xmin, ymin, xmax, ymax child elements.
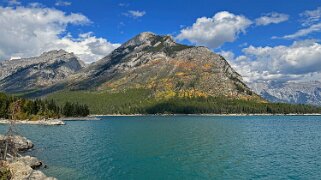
<box><xmin>0</xmin><ymin>93</ymin><xmax>89</xmax><ymax>120</ymax></box>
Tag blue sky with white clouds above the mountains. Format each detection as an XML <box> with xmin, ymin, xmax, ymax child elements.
<box><xmin>0</xmin><ymin>0</ymin><xmax>321</xmax><ymax>83</ymax></box>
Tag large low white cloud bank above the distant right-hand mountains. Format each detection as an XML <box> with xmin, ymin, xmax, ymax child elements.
<box><xmin>222</xmin><ymin>40</ymin><xmax>321</xmax><ymax>82</ymax></box>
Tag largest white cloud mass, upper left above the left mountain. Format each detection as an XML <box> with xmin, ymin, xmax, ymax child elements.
<box><xmin>0</xmin><ymin>6</ymin><xmax>119</xmax><ymax>62</ymax></box>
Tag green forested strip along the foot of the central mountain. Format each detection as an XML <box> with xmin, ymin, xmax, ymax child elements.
<box><xmin>48</xmin><ymin>89</ymin><xmax>321</xmax><ymax>114</ymax></box>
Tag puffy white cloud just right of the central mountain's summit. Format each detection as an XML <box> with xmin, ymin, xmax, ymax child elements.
<box><xmin>176</xmin><ymin>11</ymin><xmax>252</xmax><ymax>48</ymax></box>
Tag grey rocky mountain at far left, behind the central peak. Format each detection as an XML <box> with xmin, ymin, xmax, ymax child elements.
<box><xmin>0</xmin><ymin>50</ymin><xmax>85</xmax><ymax>93</ymax></box>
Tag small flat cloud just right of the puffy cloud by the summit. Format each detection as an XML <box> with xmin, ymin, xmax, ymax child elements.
<box><xmin>255</xmin><ymin>12</ymin><xmax>289</xmax><ymax>26</ymax></box>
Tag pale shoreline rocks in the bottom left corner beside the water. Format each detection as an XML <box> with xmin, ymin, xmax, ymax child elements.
<box><xmin>0</xmin><ymin>135</ymin><xmax>56</xmax><ymax>180</ymax></box>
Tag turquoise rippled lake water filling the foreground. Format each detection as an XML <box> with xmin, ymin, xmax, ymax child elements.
<box><xmin>0</xmin><ymin>116</ymin><xmax>321</xmax><ymax>180</ymax></box>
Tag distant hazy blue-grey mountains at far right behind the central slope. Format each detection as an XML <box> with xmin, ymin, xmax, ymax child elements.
<box><xmin>249</xmin><ymin>81</ymin><xmax>321</xmax><ymax>106</ymax></box>
